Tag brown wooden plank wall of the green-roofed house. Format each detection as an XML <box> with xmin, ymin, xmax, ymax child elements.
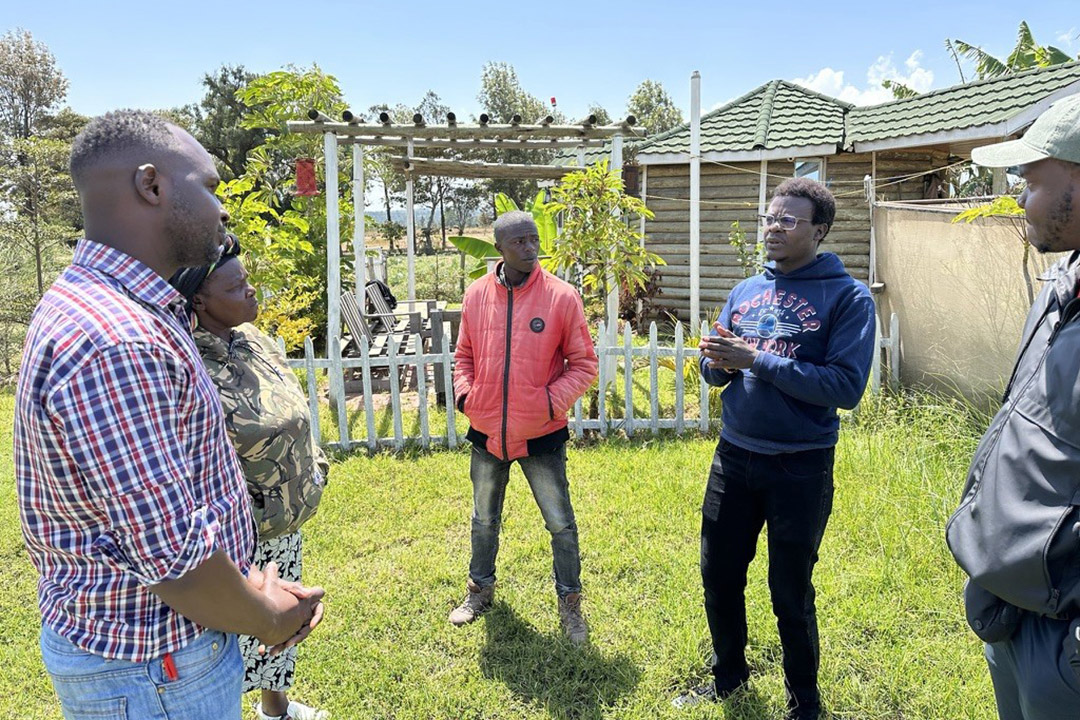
<box><xmin>645</xmin><ymin>151</ymin><xmax>948</xmax><ymax>320</ymax></box>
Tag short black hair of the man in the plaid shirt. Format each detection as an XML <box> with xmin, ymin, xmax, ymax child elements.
<box><xmin>68</xmin><ymin>110</ymin><xmax>178</xmax><ymax>186</ymax></box>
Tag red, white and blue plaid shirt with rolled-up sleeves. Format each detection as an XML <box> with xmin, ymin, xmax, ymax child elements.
<box><xmin>15</xmin><ymin>240</ymin><xmax>254</xmax><ymax>662</ymax></box>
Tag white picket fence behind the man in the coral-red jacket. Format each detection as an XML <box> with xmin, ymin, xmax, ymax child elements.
<box><xmin>279</xmin><ymin>323</ymin><xmax>712</xmax><ymax>451</ymax></box>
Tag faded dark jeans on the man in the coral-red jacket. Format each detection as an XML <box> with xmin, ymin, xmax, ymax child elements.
<box><xmin>469</xmin><ymin>445</ymin><xmax>581</xmax><ymax>597</ymax></box>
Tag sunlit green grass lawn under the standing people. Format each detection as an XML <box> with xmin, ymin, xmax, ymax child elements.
<box><xmin>0</xmin><ymin>393</ymin><xmax>995</xmax><ymax>720</ymax></box>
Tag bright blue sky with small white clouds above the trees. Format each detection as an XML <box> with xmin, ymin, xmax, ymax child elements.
<box><xmin>6</xmin><ymin>0</ymin><xmax>1080</xmax><ymax>118</ymax></box>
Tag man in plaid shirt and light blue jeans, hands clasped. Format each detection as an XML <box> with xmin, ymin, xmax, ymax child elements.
<box><xmin>15</xmin><ymin>111</ymin><xmax>323</xmax><ymax>720</ymax></box>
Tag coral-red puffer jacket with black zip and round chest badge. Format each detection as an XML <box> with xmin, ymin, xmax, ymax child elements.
<box><xmin>454</xmin><ymin>267</ymin><xmax>598</xmax><ymax>460</ymax></box>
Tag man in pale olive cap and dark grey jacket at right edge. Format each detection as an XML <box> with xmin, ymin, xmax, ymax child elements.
<box><xmin>946</xmin><ymin>95</ymin><xmax>1080</xmax><ymax>720</ymax></box>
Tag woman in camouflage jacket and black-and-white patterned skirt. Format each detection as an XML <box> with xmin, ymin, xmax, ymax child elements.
<box><xmin>170</xmin><ymin>236</ymin><xmax>329</xmax><ymax>720</ymax></box>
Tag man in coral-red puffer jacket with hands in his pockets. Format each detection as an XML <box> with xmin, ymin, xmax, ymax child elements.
<box><xmin>450</xmin><ymin>212</ymin><xmax>597</xmax><ymax>644</ymax></box>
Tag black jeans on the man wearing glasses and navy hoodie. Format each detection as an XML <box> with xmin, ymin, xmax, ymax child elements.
<box><xmin>701</xmin><ymin>439</ymin><xmax>834</xmax><ymax>708</ymax></box>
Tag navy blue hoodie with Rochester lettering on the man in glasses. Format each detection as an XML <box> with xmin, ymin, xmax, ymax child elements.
<box><xmin>701</xmin><ymin>253</ymin><xmax>874</xmax><ymax>454</ymax></box>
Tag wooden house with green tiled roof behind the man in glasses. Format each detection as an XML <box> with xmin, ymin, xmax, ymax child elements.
<box><xmin>635</xmin><ymin>62</ymin><xmax>1080</xmax><ymax>318</ymax></box>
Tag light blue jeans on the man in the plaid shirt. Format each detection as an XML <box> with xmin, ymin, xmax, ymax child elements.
<box><xmin>41</xmin><ymin>626</ymin><xmax>244</xmax><ymax>720</ymax></box>
